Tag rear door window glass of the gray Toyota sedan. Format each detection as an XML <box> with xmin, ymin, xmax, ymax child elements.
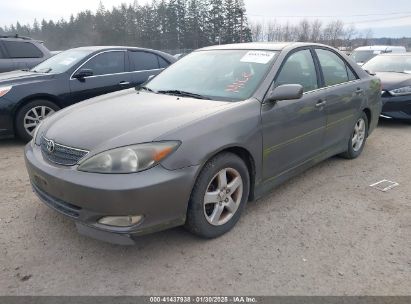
<box><xmin>315</xmin><ymin>49</ymin><xmax>357</xmax><ymax>86</ymax></box>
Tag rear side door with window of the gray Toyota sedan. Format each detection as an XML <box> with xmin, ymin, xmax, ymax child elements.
<box><xmin>315</xmin><ymin>48</ymin><xmax>365</xmax><ymax>147</ymax></box>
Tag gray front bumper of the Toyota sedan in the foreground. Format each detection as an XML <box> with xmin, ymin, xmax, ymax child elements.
<box><xmin>25</xmin><ymin>144</ymin><xmax>198</xmax><ymax>245</ymax></box>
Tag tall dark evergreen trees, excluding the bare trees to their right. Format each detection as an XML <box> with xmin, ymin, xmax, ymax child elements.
<box><xmin>0</xmin><ymin>0</ymin><xmax>251</xmax><ymax>50</ymax></box>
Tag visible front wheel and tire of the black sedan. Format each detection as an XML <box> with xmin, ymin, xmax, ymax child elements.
<box><xmin>15</xmin><ymin>100</ymin><xmax>60</xmax><ymax>142</ymax></box>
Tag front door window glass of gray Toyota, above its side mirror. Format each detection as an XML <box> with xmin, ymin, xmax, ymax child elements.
<box><xmin>275</xmin><ymin>50</ymin><xmax>318</xmax><ymax>92</ymax></box>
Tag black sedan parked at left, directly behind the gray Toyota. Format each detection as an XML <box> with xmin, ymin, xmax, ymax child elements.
<box><xmin>0</xmin><ymin>46</ymin><xmax>176</xmax><ymax>140</ymax></box>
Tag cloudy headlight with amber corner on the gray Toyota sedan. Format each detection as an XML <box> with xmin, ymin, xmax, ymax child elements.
<box><xmin>78</xmin><ymin>141</ymin><xmax>180</xmax><ymax>174</ymax></box>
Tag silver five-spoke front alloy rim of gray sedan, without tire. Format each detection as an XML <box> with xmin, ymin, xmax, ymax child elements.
<box><xmin>203</xmin><ymin>168</ymin><xmax>243</xmax><ymax>226</ymax></box>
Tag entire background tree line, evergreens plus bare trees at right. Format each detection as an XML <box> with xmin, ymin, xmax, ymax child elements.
<box><xmin>0</xmin><ymin>0</ymin><xmax>411</xmax><ymax>53</ymax></box>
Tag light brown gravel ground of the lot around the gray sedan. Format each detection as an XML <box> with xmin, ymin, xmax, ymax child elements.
<box><xmin>0</xmin><ymin>122</ymin><xmax>411</xmax><ymax>295</ymax></box>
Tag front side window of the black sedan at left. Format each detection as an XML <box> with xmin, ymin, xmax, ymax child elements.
<box><xmin>81</xmin><ymin>51</ymin><xmax>125</xmax><ymax>76</ymax></box>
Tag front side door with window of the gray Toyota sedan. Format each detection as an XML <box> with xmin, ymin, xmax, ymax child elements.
<box><xmin>261</xmin><ymin>48</ymin><xmax>326</xmax><ymax>180</ymax></box>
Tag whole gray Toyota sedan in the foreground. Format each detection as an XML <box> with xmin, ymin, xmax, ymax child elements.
<box><xmin>25</xmin><ymin>43</ymin><xmax>381</xmax><ymax>244</ymax></box>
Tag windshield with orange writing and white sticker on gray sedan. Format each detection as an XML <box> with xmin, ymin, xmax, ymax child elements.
<box><xmin>146</xmin><ymin>50</ymin><xmax>276</xmax><ymax>101</ymax></box>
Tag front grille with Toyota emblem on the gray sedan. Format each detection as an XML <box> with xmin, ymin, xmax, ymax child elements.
<box><xmin>40</xmin><ymin>136</ymin><xmax>88</xmax><ymax>166</ymax></box>
